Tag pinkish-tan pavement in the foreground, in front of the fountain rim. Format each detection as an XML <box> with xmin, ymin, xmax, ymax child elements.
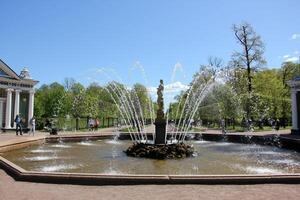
<box><xmin>0</xmin><ymin>170</ymin><xmax>300</xmax><ymax>200</ymax></box>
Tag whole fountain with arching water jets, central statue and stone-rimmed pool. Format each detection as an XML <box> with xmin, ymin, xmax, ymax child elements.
<box><xmin>0</xmin><ymin>69</ymin><xmax>300</xmax><ymax>184</ymax></box>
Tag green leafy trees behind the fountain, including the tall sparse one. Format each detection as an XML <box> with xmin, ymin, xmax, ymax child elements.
<box><xmin>34</xmin><ymin>23</ymin><xmax>300</xmax><ymax>131</ymax></box>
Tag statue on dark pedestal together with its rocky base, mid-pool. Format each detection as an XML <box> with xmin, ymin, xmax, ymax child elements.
<box><xmin>125</xmin><ymin>80</ymin><xmax>194</xmax><ymax>159</ymax></box>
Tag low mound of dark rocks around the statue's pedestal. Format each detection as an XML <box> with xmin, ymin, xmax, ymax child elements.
<box><xmin>125</xmin><ymin>143</ymin><xmax>194</xmax><ymax>159</ymax></box>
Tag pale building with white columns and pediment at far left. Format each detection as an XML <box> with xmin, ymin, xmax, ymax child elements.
<box><xmin>0</xmin><ymin>59</ymin><xmax>38</xmax><ymax>130</ymax></box>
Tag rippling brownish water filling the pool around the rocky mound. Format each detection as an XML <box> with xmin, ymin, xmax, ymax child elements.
<box><xmin>2</xmin><ymin>140</ymin><xmax>300</xmax><ymax>175</ymax></box>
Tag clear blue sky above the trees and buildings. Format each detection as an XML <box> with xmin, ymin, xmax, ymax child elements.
<box><xmin>0</xmin><ymin>0</ymin><xmax>300</xmax><ymax>91</ymax></box>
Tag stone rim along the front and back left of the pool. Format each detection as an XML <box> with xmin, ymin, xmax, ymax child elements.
<box><xmin>0</xmin><ymin>134</ymin><xmax>300</xmax><ymax>185</ymax></box>
